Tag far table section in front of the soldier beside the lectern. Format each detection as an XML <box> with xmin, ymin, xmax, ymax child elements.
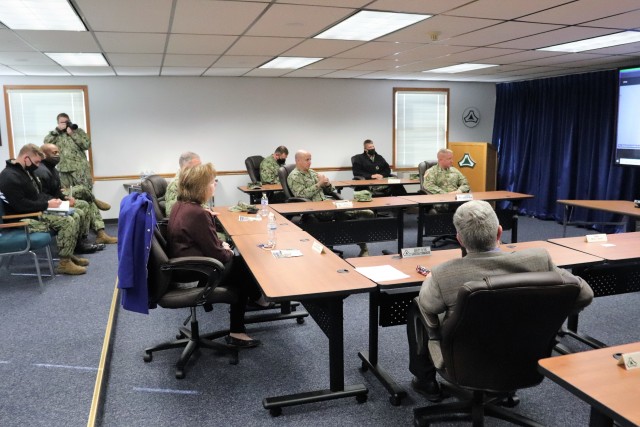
<box><xmin>400</xmin><ymin>191</ymin><xmax>534</xmax><ymax>246</ymax></box>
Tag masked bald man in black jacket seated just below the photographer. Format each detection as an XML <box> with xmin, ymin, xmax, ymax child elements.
<box><xmin>35</xmin><ymin>144</ymin><xmax>118</xmax><ymax>247</ymax></box>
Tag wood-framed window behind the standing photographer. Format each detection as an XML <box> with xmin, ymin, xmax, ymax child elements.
<box><xmin>4</xmin><ymin>86</ymin><xmax>90</xmax><ymax>167</ymax></box>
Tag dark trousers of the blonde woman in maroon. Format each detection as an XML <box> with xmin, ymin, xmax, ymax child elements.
<box><xmin>220</xmin><ymin>256</ymin><xmax>261</xmax><ymax>333</ymax></box>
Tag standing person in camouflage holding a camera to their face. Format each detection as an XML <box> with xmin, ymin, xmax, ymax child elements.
<box><xmin>44</xmin><ymin>113</ymin><xmax>111</xmax><ymax>211</ymax></box>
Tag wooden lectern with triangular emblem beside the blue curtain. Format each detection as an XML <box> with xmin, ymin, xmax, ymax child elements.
<box><xmin>448</xmin><ymin>142</ymin><xmax>498</xmax><ymax>191</ymax></box>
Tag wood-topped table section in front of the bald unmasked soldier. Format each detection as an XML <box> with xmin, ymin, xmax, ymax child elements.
<box><xmin>269</xmin><ymin>197</ymin><xmax>417</xmax><ymax>252</ymax></box>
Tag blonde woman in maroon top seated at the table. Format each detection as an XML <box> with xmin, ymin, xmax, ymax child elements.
<box><xmin>168</xmin><ymin>163</ymin><xmax>261</xmax><ymax>347</ymax></box>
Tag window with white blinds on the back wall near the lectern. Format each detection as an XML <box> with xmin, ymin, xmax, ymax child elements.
<box><xmin>393</xmin><ymin>88</ymin><xmax>449</xmax><ymax>168</ymax></box>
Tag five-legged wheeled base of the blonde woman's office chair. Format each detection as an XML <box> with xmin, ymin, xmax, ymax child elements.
<box><xmin>143</xmin><ymin>307</ymin><xmax>239</xmax><ymax>380</ymax></box>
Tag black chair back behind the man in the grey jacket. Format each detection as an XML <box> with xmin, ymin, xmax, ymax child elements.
<box><xmin>441</xmin><ymin>272</ymin><xmax>580</xmax><ymax>391</ymax></box>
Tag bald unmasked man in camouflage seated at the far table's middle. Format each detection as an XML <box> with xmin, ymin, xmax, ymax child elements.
<box><xmin>287</xmin><ymin>150</ymin><xmax>374</xmax><ymax>256</ymax></box>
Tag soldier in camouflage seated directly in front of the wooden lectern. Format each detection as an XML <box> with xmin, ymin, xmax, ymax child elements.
<box><xmin>424</xmin><ymin>148</ymin><xmax>471</xmax><ymax>212</ymax></box>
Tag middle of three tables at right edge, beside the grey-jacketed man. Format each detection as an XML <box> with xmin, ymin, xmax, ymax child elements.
<box><xmin>549</xmin><ymin>232</ymin><xmax>640</xmax><ymax>348</ymax></box>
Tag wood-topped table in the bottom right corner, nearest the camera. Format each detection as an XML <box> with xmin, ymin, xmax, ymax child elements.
<box><xmin>538</xmin><ymin>342</ymin><xmax>640</xmax><ymax>427</ymax></box>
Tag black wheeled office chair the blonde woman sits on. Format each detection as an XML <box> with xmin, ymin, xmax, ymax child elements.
<box><xmin>144</xmin><ymin>229</ymin><xmax>238</xmax><ymax>379</ymax></box>
